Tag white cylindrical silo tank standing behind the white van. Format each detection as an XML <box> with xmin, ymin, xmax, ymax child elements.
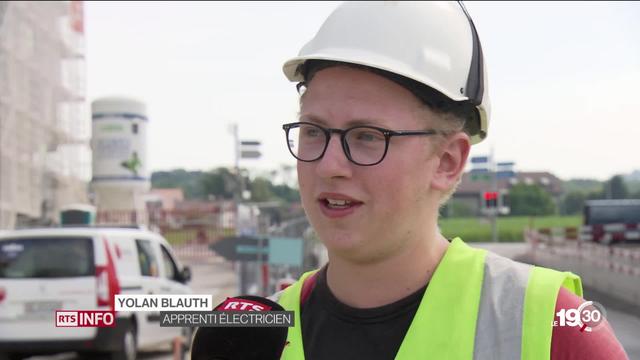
<box><xmin>91</xmin><ymin>97</ymin><xmax>150</xmax><ymax>218</ymax></box>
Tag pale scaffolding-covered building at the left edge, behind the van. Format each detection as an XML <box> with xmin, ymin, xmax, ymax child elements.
<box><xmin>0</xmin><ymin>1</ymin><xmax>91</xmax><ymax>229</ymax></box>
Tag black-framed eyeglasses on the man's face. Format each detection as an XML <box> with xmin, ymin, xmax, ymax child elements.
<box><xmin>282</xmin><ymin>122</ymin><xmax>446</xmax><ymax>166</ymax></box>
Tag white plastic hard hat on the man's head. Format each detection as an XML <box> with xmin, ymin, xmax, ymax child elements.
<box><xmin>283</xmin><ymin>1</ymin><xmax>490</xmax><ymax>144</ymax></box>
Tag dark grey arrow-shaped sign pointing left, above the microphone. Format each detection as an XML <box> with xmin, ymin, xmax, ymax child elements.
<box><xmin>209</xmin><ymin>236</ymin><xmax>269</xmax><ymax>261</ymax></box>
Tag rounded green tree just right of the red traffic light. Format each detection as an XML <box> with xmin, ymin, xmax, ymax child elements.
<box><xmin>509</xmin><ymin>184</ymin><xmax>556</xmax><ymax>216</ymax></box>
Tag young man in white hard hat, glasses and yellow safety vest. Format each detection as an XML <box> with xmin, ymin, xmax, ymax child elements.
<box><xmin>274</xmin><ymin>2</ymin><xmax>626</xmax><ymax>360</ymax></box>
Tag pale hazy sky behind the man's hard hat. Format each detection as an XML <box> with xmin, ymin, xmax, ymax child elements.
<box><xmin>85</xmin><ymin>1</ymin><xmax>640</xmax><ymax>180</ymax></box>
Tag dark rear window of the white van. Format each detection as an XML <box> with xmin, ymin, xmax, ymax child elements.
<box><xmin>0</xmin><ymin>237</ymin><xmax>95</xmax><ymax>279</ymax></box>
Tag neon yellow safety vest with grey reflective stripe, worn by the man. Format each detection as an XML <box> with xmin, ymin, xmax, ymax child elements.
<box><xmin>275</xmin><ymin>238</ymin><xmax>582</xmax><ymax>360</ymax></box>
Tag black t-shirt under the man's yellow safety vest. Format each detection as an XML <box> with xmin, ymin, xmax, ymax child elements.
<box><xmin>300</xmin><ymin>266</ymin><xmax>427</xmax><ymax>360</ymax></box>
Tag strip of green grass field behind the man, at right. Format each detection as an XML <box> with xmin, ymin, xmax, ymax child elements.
<box><xmin>439</xmin><ymin>216</ymin><xmax>582</xmax><ymax>242</ymax></box>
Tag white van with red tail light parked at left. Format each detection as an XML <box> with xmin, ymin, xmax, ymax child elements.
<box><xmin>0</xmin><ymin>227</ymin><xmax>191</xmax><ymax>360</ymax></box>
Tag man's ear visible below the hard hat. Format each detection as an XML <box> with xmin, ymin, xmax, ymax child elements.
<box><xmin>431</xmin><ymin>132</ymin><xmax>471</xmax><ymax>192</ymax></box>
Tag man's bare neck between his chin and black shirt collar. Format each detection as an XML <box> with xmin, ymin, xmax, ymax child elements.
<box><xmin>327</xmin><ymin>234</ymin><xmax>449</xmax><ymax>308</ymax></box>
